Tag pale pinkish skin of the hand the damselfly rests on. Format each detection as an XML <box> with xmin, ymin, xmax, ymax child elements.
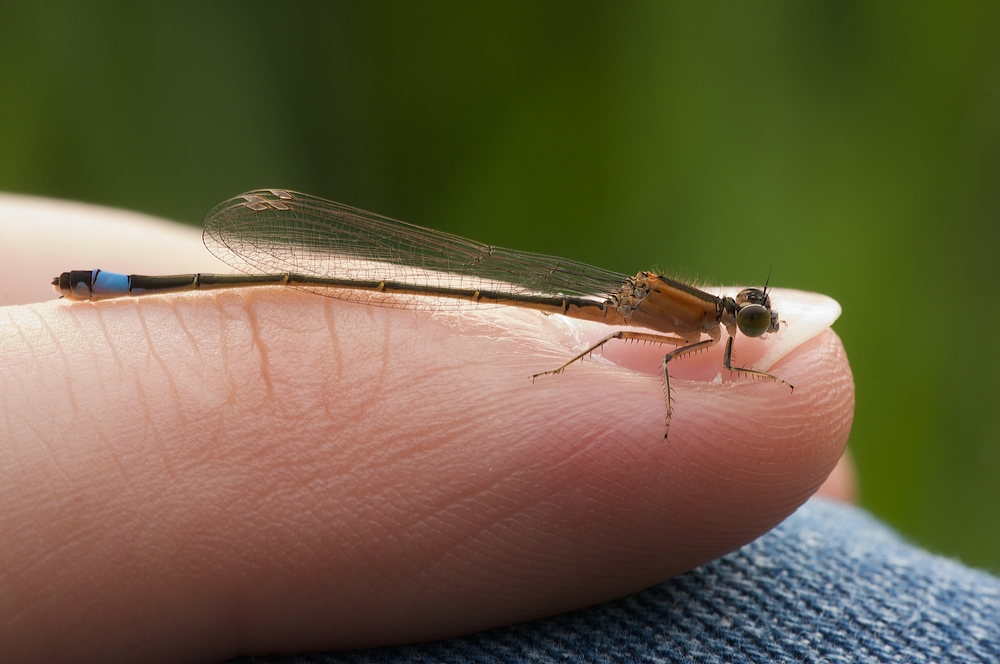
<box><xmin>0</xmin><ymin>196</ymin><xmax>855</xmax><ymax>662</ymax></box>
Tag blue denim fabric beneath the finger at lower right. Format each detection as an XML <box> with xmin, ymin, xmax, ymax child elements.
<box><xmin>233</xmin><ymin>499</ymin><xmax>1000</xmax><ymax>664</ymax></box>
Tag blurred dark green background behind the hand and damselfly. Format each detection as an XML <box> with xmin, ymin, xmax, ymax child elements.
<box><xmin>0</xmin><ymin>1</ymin><xmax>1000</xmax><ymax>571</ymax></box>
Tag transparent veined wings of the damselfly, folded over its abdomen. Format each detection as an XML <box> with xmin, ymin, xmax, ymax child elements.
<box><xmin>204</xmin><ymin>189</ymin><xmax>627</xmax><ymax>308</ymax></box>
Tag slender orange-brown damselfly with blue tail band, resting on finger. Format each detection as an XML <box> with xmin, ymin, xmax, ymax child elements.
<box><xmin>52</xmin><ymin>189</ymin><xmax>792</xmax><ymax>438</ymax></box>
